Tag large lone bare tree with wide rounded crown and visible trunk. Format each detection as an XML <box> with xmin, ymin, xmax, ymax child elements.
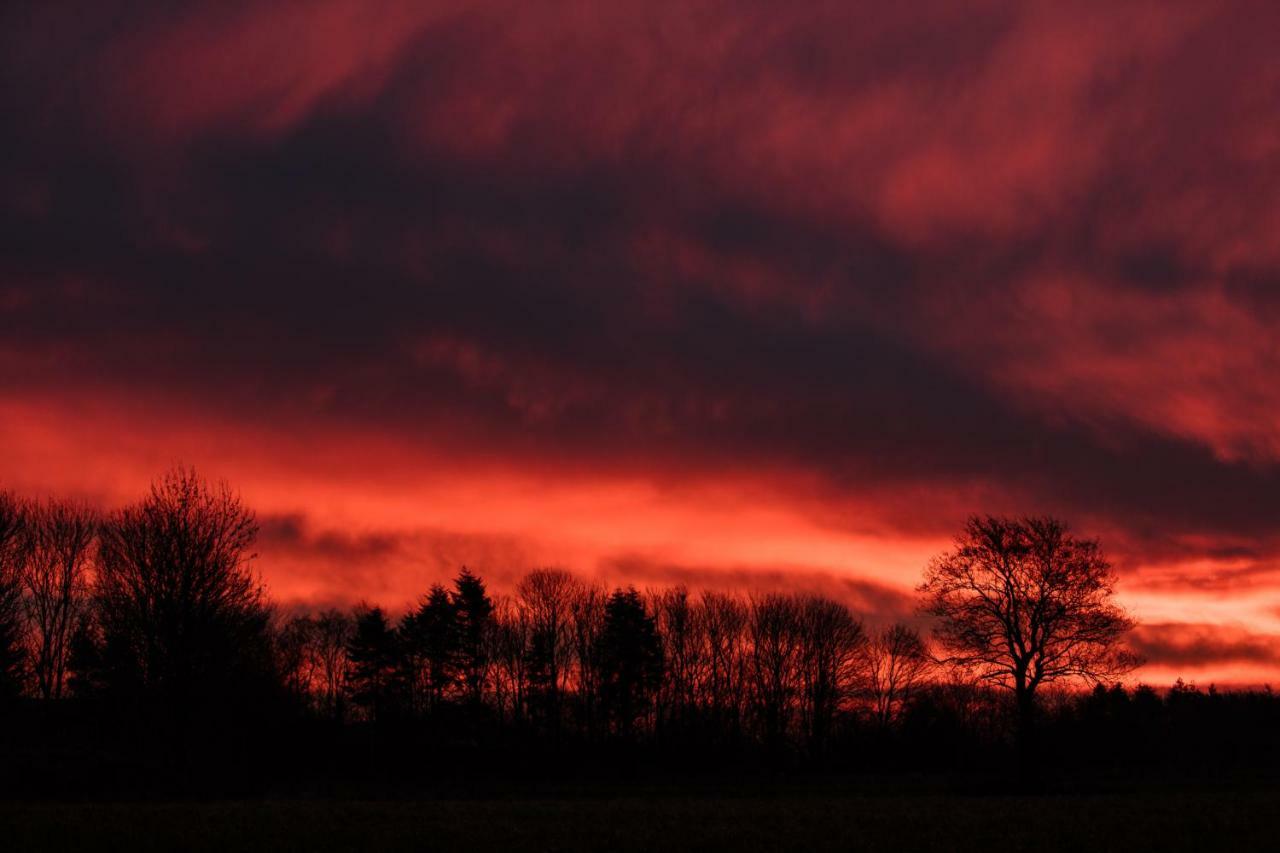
<box><xmin>919</xmin><ymin>516</ymin><xmax>1138</xmax><ymax>771</ymax></box>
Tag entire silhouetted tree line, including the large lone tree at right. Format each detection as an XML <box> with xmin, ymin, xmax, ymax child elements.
<box><xmin>0</xmin><ymin>470</ymin><xmax>1275</xmax><ymax>788</ymax></box>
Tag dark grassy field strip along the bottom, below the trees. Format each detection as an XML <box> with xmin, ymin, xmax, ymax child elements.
<box><xmin>0</xmin><ymin>790</ymin><xmax>1280</xmax><ymax>853</ymax></box>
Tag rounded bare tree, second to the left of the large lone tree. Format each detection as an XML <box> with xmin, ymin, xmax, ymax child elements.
<box><xmin>797</xmin><ymin>596</ymin><xmax>867</xmax><ymax>756</ymax></box>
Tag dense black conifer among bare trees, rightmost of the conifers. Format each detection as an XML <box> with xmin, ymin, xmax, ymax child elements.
<box><xmin>596</xmin><ymin>587</ymin><xmax>662</xmax><ymax>736</ymax></box>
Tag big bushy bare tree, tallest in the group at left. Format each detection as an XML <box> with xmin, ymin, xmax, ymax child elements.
<box><xmin>93</xmin><ymin>469</ymin><xmax>270</xmax><ymax>725</ymax></box>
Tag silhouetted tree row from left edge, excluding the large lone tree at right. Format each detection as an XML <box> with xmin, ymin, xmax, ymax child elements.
<box><xmin>0</xmin><ymin>471</ymin><xmax>933</xmax><ymax>749</ymax></box>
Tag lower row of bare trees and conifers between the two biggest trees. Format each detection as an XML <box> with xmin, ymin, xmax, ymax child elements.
<box><xmin>279</xmin><ymin>569</ymin><xmax>931</xmax><ymax>749</ymax></box>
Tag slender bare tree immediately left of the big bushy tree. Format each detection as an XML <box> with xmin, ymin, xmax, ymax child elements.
<box><xmin>22</xmin><ymin>501</ymin><xmax>97</xmax><ymax>699</ymax></box>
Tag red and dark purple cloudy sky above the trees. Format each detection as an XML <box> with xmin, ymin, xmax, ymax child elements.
<box><xmin>0</xmin><ymin>0</ymin><xmax>1280</xmax><ymax>684</ymax></box>
